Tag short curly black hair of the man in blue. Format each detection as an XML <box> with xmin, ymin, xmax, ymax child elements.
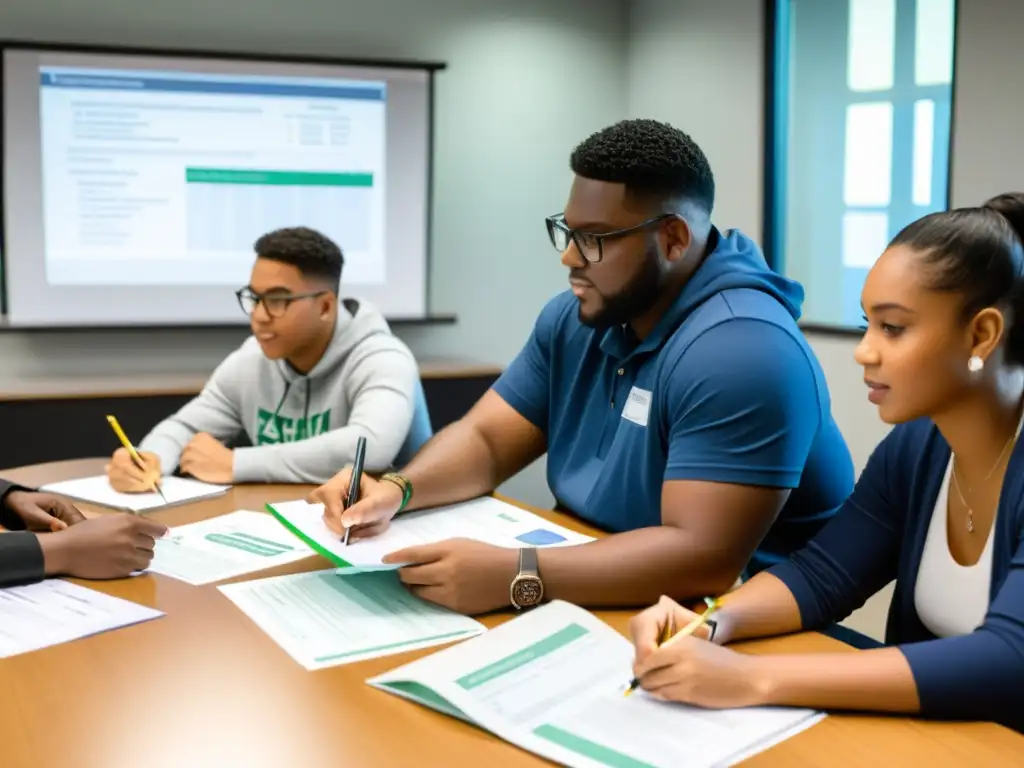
<box><xmin>569</xmin><ymin>119</ymin><xmax>715</xmax><ymax>215</ymax></box>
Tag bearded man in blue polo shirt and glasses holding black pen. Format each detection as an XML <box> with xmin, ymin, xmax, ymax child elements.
<box><xmin>312</xmin><ymin>120</ymin><xmax>853</xmax><ymax>613</ymax></box>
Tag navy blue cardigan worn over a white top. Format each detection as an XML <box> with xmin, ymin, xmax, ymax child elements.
<box><xmin>769</xmin><ymin>420</ymin><xmax>1024</xmax><ymax>732</ymax></box>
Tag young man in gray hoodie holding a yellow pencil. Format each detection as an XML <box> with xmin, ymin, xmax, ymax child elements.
<box><xmin>108</xmin><ymin>227</ymin><xmax>421</xmax><ymax>493</ymax></box>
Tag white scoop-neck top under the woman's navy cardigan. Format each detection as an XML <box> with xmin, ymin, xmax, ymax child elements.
<box><xmin>913</xmin><ymin>416</ymin><xmax>1024</xmax><ymax>637</ymax></box>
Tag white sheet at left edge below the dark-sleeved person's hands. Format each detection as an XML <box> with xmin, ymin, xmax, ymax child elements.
<box><xmin>0</xmin><ymin>579</ymin><xmax>164</xmax><ymax>658</ymax></box>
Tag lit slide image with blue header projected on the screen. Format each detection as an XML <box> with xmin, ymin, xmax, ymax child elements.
<box><xmin>39</xmin><ymin>67</ymin><xmax>388</xmax><ymax>288</ymax></box>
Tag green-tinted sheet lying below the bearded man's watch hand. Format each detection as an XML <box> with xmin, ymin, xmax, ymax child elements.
<box><xmin>218</xmin><ymin>570</ymin><xmax>485</xmax><ymax>670</ymax></box>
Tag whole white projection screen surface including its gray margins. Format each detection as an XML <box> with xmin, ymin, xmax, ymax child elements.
<box><xmin>0</xmin><ymin>44</ymin><xmax>435</xmax><ymax>328</ymax></box>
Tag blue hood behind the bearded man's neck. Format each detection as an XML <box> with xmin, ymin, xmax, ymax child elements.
<box><xmin>676</xmin><ymin>229</ymin><xmax>804</xmax><ymax>321</ymax></box>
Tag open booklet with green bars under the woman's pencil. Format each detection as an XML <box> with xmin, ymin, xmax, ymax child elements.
<box><xmin>368</xmin><ymin>601</ymin><xmax>823</xmax><ymax>768</ymax></box>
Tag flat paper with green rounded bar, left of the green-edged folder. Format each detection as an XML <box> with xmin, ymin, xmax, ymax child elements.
<box><xmin>148</xmin><ymin>510</ymin><xmax>313</xmax><ymax>587</ymax></box>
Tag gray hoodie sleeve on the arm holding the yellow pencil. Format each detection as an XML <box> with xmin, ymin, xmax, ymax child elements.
<box><xmin>138</xmin><ymin>347</ymin><xmax>245</xmax><ymax>475</ymax></box>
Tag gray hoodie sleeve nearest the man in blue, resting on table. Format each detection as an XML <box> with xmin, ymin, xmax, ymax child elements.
<box><xmin>234</xmin><ymin>344</ymin><xmax>420</xmax><ymax>484</ymax></box>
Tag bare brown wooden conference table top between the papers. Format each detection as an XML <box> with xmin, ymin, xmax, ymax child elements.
<box><xmin>0</xmin><ymin>459</ymin><xmax>1024</xmax><ymax>768</ymax></box>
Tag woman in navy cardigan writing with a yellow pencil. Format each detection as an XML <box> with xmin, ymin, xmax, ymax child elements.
<box><xmin>631</xmin><ymin>195</ymin><xmax>1024</xmax><ymax>731</ymax></box>
